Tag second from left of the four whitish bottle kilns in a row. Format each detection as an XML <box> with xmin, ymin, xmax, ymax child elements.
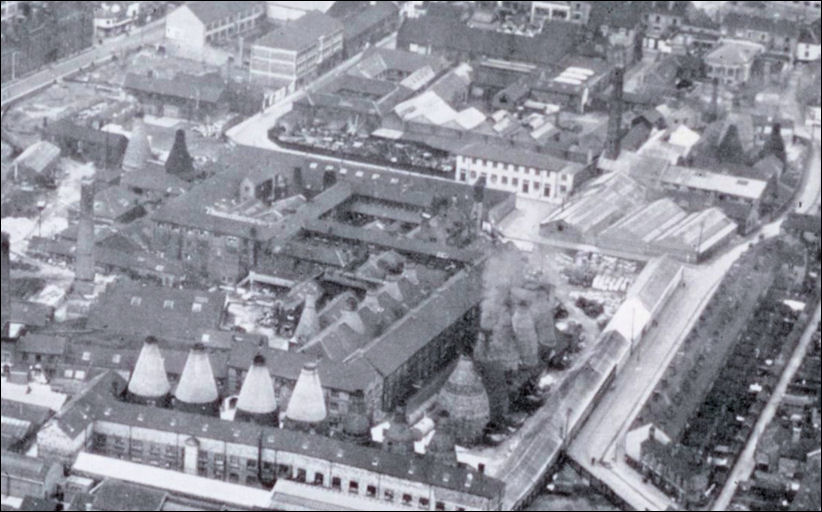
<box><xmin>174</xmin><ymin>343</ymin><xmax>220</xmax><ymax>416</ymax></box>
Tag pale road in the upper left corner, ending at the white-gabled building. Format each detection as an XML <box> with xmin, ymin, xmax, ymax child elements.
<box><xmin>0</xmin><ymin>19</ymin><xmax>165</xmax><ymax>106</ymax></box>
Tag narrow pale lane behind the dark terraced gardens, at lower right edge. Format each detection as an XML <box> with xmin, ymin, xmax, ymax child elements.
<box><xmin>712</xmin><ymin>303</ymin><xmax>822</xmax><ymax>510</ymax></box>
